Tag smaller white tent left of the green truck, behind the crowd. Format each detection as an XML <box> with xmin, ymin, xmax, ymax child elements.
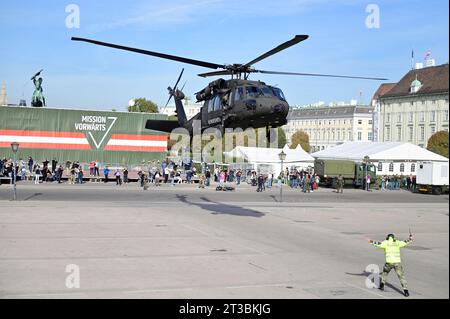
<box><xmin>224</xmin><ymin>145</ymin><xmax>314</xmax><ymax>174</ymax></box>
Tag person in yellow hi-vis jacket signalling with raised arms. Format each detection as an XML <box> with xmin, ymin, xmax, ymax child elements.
<box><xmin>369</xmin><ymin>234</ymin><xmax>413</xmax><ymax>297</ymax></box>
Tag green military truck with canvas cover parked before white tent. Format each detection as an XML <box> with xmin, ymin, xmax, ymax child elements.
<box><xmin>314</xmin><ymin>159</ymin><xmax>376</xmax><ymax>188</ymax></box>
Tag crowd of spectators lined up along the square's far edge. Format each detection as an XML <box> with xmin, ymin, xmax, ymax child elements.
<box><xmin>0</xmin><ymin>157</ymin><xmax>416</xmax><ymax>193</ymax></box>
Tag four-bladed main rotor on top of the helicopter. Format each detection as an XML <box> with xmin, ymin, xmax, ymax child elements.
<box><xmin>72</xmin><ymin>35</ymin><xmax>387</xmax><ymax>81</ymax></box>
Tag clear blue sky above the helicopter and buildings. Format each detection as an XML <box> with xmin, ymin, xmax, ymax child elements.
<box><xmin>0</xmin><ymin>0</ymin><xmax>449</xmax><ymax>111</ymax></box>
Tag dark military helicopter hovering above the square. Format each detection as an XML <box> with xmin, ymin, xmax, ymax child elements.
<box><xmin>72</xmin><ymin>35</ymin><xmax>387</xmax><ymax>138</ymax></box>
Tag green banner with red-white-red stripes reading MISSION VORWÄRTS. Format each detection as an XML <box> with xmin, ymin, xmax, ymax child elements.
<box><xmin>0</xmin><ymin>107</ymin><xmax>167</xmax><ymax>165</ymax></box>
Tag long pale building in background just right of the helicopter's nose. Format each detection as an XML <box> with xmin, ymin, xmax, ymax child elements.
<box><xmin>283</xmin><ymin>105</ymin><xmax>374</xmax><ymax>152</ymax></box>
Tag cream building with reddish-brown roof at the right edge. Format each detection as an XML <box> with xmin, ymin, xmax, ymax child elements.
<box><xmin>378</xmin><ymin>64</ymin><xmax>449</xmax><ymax>147</ymax></box>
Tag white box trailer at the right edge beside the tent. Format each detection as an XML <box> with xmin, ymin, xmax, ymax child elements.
<box><xmin>416</xmin><ymin>162</ymin><xmax>449</xmax><ymax>195</ymax></box>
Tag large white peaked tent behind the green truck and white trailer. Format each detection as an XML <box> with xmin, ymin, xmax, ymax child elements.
<box><xmin>311</xmin><ymin>142</ymin><xmax>448</xmax><ymax>175</ymax></box>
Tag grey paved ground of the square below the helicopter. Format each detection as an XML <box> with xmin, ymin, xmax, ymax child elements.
<box><xmin>0</xmin><ymin>183</ymin><xmax>449</xmax><ymax>299</ymax></box>
